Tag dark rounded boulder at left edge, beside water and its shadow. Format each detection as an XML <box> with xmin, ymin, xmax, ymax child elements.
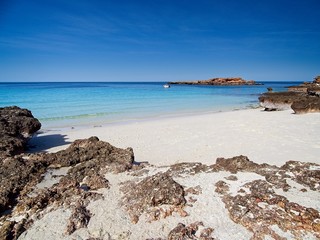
<box><xmin>0</xmin><ymin>106</ymin><xmax>41</xmax><ymax>158</ymax></box>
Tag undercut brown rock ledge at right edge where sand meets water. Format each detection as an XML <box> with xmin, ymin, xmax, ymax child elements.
<box><xmin>259</xmin><ymin>76</ymin><xmax>320</xmax><ymax>114</ymax></box>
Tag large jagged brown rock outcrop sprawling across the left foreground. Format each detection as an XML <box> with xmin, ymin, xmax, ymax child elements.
<box><xmin>0</xmin><ymin>137</ymin><xmax>134</xmax><ymax>239</ymax></box>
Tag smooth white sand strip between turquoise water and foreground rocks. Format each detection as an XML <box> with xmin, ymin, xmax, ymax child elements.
<box><xmin>30</xmin><ymin>108</ymin><xmax>320</xmax><ymax>166</ymax></box>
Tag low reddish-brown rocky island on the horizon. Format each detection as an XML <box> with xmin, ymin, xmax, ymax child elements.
<box><xmin>169</xmin><ymin>77</ymin><xmax>261</xmax><ymax>86</ymax></box>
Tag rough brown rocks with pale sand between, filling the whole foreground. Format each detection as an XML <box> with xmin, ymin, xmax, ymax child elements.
<box><xmin>0</xmin><ymin>108</ymin><xmax>320</xmax><ymax>240</ymax></box>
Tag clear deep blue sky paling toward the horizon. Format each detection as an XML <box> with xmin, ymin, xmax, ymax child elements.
<box><xmin>0</xmin><ymin>0</ymin><xmax>320</xmax><ymax>82</ymax></box>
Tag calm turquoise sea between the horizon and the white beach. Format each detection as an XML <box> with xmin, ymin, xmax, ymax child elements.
<box><xmin>0</xmin><ymin>82</ymin><xmax>298</xmax><ymax>129</ymax></box>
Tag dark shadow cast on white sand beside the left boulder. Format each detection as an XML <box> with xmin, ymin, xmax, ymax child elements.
<box><xmin>27</xmin><ymin>134</ymin><xmax>71</xmax><ymax>153</ymax></box>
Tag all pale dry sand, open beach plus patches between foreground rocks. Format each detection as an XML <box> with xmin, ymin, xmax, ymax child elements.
<box><xmin>19</xmin><ymin>109</ymin><xmax>320</xmax><ymax>240</ymax></box>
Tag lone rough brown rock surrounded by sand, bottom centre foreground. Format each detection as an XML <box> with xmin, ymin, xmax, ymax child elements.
<box><xmin>121</xmin><ymin>173</ymin><xmax>186</xmax><ymax>223</ymax></box>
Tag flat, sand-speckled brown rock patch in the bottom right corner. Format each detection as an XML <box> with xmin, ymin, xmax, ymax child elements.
<box><xmin>218</xmin><ymin>180</ymin><xmax>320</xmax><ymax>239</ymax></box>
